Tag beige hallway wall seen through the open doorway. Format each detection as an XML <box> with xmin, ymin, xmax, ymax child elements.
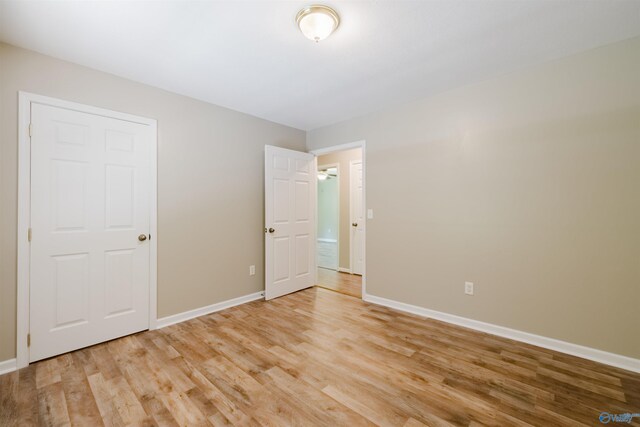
<box><xmin>318</xmin><ymin>149</ymin><xmax>362</xmax><ymax>270</ymax></box>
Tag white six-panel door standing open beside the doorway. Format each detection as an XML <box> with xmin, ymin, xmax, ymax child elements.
<box><xmin>265</xmin><ymin>145</ymin><xmax>316</xmax><ymax>300</ymax></box>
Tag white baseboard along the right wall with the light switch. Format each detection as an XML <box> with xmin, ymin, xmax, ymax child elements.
<box><xmin>363</xmin><ymin>294</ymin><xmax>640</xmax><ymax>373</ymax></box>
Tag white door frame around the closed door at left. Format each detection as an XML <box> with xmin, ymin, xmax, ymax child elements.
<box><xmin>16</xmin><ymin>91</ymin><xmax>158</xmax><ymax>369</ymax></box>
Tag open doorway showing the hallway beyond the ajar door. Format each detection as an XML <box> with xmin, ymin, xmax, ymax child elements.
<box><xmin>315</xmin><ymin>144</ymin><xmax>366</xmax><ymax>298</ymax></box>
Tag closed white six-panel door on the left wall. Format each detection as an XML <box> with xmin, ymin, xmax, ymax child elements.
<box><xmin>29</xmin><ymin>103</ymin><xmax>152</xmax><ymax>361</ymax></box>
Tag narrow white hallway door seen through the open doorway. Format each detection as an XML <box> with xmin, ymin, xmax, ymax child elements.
<box><xmin>350</xmin><ymin>161</ymin><xmax>366</xmax><ymax>275</ymax></box>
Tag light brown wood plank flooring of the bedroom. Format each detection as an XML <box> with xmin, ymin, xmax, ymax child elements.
<box><xmin>0</xmin><ymin>288</ymin><xmax>640</xmax><ymax>427</ymax></box>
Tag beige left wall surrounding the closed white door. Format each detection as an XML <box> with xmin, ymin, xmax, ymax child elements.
<box><xmin>0</xmin><ymin>44</ymin><xmax>305</xmax><ymax>361</ymax></box>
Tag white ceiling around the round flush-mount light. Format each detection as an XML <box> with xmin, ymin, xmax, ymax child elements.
<box><xmin>0</xmin><ymin>0</ymin><xmax>640</xmax><ymax>130</ymax></box>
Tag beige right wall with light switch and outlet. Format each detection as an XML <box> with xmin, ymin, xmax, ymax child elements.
<box><xmin>307</xmin><ymin>38</ymin><xmax>640</xmax><ymax>358</ymax></box>
